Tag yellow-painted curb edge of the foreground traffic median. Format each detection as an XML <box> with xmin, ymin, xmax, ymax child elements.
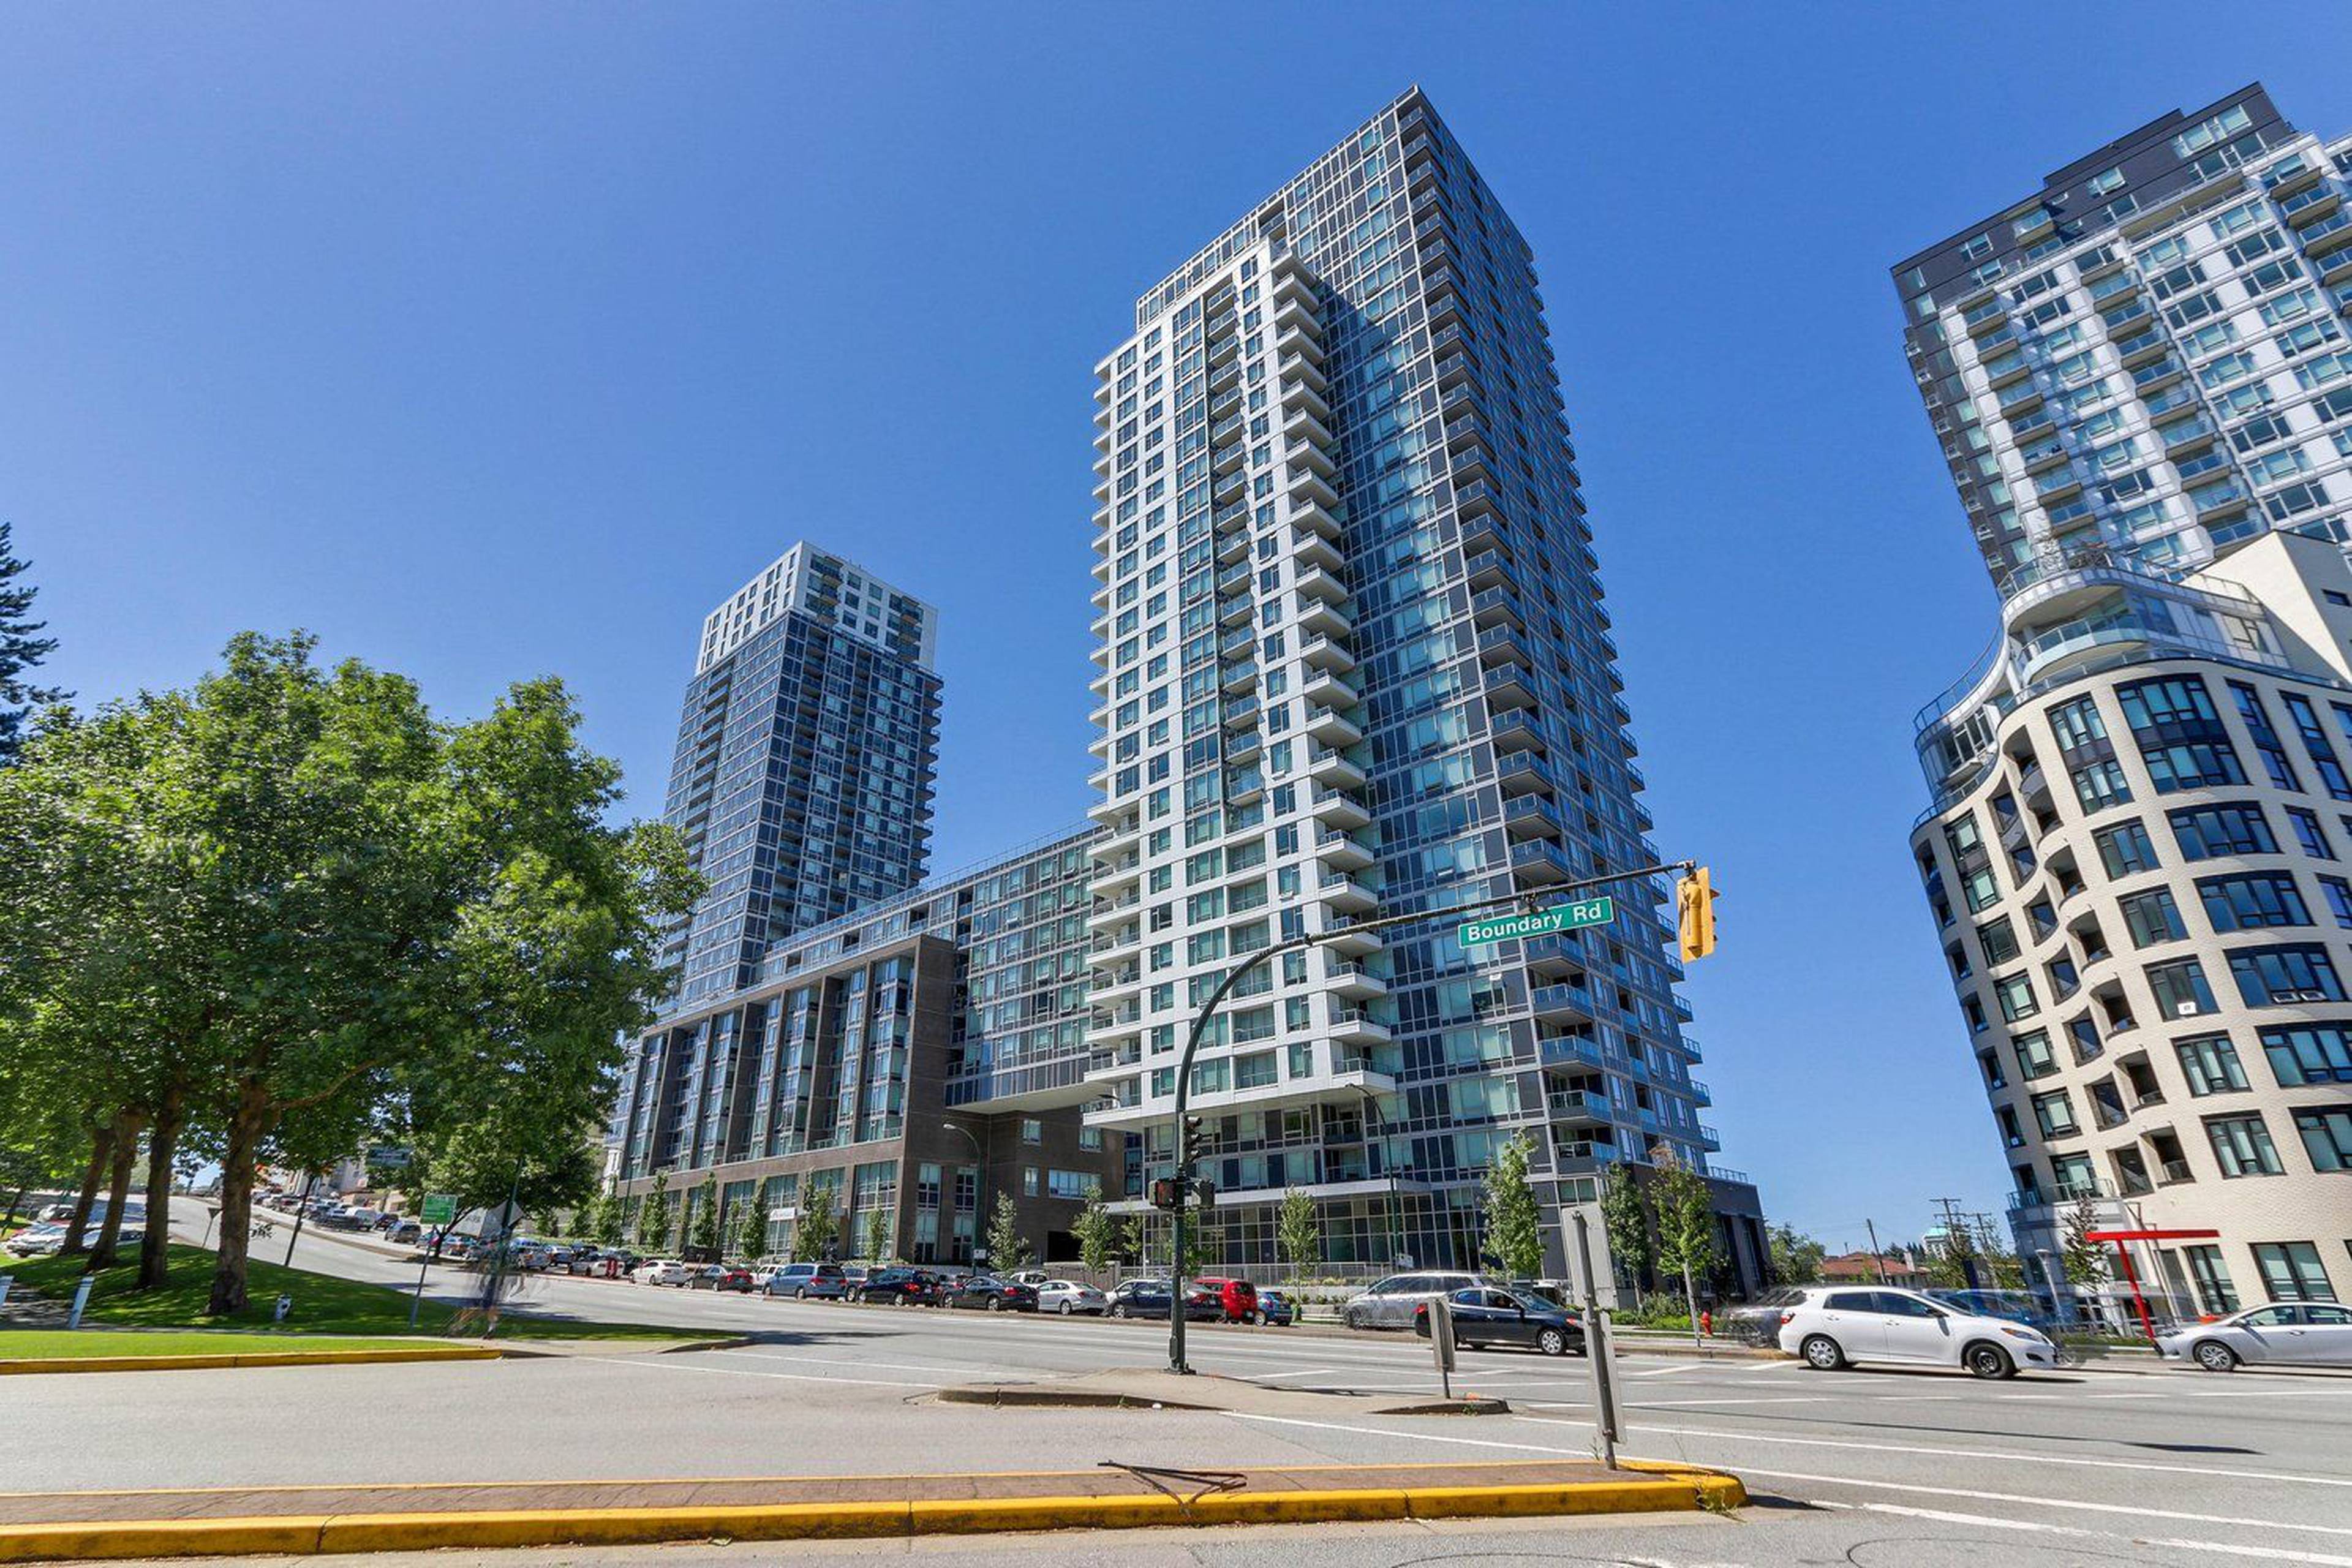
<box><xmin>0</xmin><ymin>1469</ymin><xmax>1747</xmax><ymax>1563</ymax></box>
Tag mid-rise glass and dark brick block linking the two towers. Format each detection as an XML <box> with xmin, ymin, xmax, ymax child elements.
<box><xmin>614</xmin><ymin>827</ymin><xmax>1125</xmax><ymax>1262</ymax></box>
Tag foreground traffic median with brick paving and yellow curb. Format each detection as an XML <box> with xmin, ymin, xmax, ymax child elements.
<box><xmin>0</xmin><ymin>1460</ymin><xmax>1747</xmax><ymax>1561</ymax></box>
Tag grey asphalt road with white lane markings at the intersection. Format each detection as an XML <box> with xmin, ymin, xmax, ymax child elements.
<box><xmin>124</xmin><ymin>1194</ymin><xmax>2352</xmax><ymax>1568</ymax></box>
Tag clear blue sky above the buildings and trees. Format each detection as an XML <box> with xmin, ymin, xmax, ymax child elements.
<box><xmin>13</xmin><ymin>0</ymin><xmax>2352</xmax><ymax>1243</ymax></box>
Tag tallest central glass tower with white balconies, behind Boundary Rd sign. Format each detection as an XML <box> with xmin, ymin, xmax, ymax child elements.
<box><xmin>1089</xmin><ymin>92</ymin><xmax>1762</xmax><ymax>1281</ymax></box>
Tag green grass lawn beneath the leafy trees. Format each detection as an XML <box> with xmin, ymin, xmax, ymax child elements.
<box><xmin>0</xmin><ymin>1243</ymin><xmax>717</xmax><ymax>1354</ymax></box>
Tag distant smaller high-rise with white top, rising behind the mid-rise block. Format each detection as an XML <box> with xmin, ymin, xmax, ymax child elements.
<box><xmin>666</xmin><ymin>543</ymin><xmax>938</xmax><ymax>1004</ymax></box>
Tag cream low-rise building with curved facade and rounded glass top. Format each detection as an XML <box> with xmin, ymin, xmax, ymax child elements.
<box><xmin>1912</xmin><ymin>533</ymin><xmax>2352</xmax><ymax>1312</ymax></box>
